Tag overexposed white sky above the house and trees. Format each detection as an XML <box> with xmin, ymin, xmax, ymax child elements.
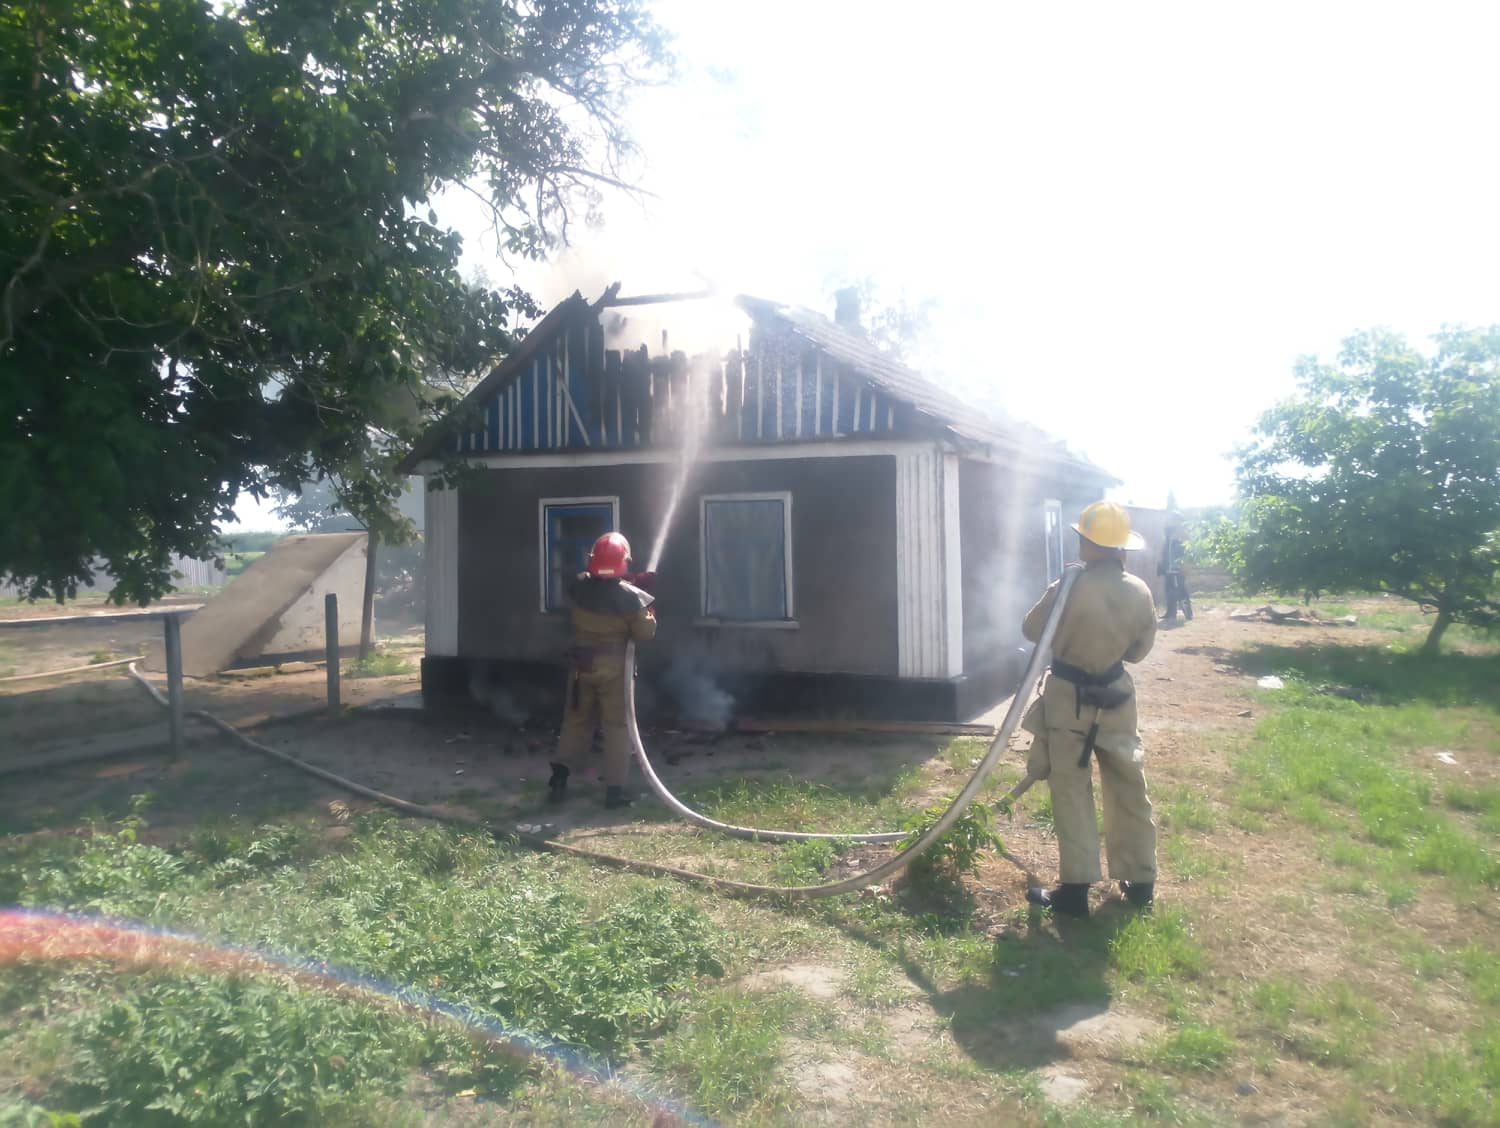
<box><xmin>231</xmin><ymin>0</ymin><xmax>1500</xmax><ymax>528</ymax></box>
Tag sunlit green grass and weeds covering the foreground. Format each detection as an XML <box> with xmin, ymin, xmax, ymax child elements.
<box><xmin>0</xmin><ymin>629</ymin><xmax>1500</xmax><ymax>1128</ymax></box>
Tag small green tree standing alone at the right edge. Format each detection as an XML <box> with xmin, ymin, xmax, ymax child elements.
<box><xmin>1215</xmin><ymin>327</ymin><xmax>1500</xmax><ymax>653</ymax></box>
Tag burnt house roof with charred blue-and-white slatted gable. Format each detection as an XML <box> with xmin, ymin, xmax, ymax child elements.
<box><xmin>408</xmin><ymin>284</ymin><xmax>1103</xmax><ymax>473</ymax></box>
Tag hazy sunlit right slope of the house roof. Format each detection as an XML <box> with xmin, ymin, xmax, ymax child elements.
<box><xmin>735</xmin><ymin>294</ymin><xmax>1119</xmax><ymax>485</ymax></box>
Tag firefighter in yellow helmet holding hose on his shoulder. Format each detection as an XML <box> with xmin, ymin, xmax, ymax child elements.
<box><xmin>1022</xmin><ymin>501</ymin><xmax>1157</xmax><ymax>917</ymax></box>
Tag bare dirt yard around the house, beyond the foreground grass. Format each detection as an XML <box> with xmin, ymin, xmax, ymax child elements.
<box><xmin>0</xmin><ymin>600</ymin><xmax>1416</xmax><ymax>858</ymax></box>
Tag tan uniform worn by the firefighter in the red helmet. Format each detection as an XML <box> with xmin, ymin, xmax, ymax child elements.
<box><xmin>558</xmin><ymin>573</ymin><xmax>656</xmax><ymax>788</ymax></box>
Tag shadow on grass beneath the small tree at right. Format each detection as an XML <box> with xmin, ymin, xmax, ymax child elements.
<box><xmin>1241</xmin><ymin>647</ymin><xmax>1500</xmax><ymax>708</ymax></box>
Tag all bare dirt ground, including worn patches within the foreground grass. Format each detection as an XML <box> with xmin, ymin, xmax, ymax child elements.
<box><xmin>0</xmin><ymin>600</ymin><xmax>1476</xmax><ymax>1124</ymax></box>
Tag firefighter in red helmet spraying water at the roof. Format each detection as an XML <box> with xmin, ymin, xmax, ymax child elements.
<box><xmin>548</xmin><ymin>533</ymin><xmax>656</xmax><ymax>807</ymax></box>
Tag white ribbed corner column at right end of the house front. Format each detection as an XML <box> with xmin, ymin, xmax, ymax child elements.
<box><xmin>896</xmin><ymin>447</ymin><xmax>963</xmax><ymax>678</ymax></box>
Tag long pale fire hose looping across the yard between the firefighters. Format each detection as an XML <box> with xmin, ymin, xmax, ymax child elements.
<box><xmin>129</xmin><ymin>567</ymin><xmax>1079</xmax><ymax>900</ymax></box>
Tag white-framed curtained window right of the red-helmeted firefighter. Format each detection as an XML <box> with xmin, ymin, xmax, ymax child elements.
<box><xmin>702</xmin><ymin>494</ymin><xmax>792</xmax><ymax>623</ymax></box>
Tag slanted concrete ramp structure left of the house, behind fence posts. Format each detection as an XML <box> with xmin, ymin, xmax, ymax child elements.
<box><xmin>146</xmin><ymin>533</ymin><xmax>368</xmax><ymax>678</ymax></box>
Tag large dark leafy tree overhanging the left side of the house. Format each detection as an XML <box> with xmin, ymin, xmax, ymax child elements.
<box><xmin>0</xmin><ymin>0</ymin><xmax>668</xmax><ymax>602</ymax></box>
